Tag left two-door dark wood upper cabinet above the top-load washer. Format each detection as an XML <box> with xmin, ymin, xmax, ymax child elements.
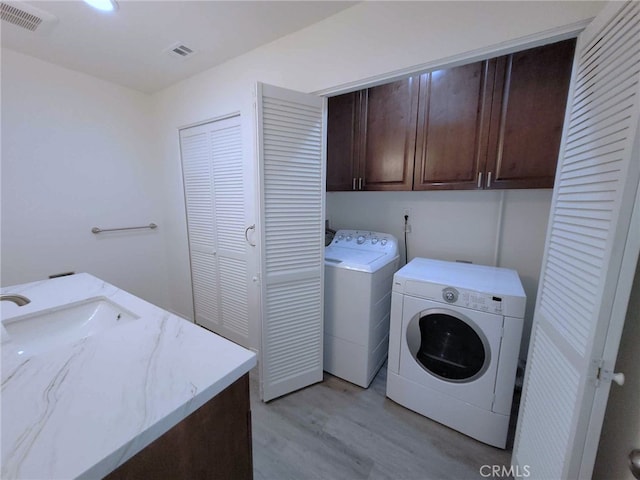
<box><xmin>327</xmin><ymin>77</ymin><xmax>418</xmax><ymax>191</ymax></box>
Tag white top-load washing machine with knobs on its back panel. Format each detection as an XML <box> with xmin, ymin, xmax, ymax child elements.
<box><xmin>324</xmin><ymin>230</ymin><xmax>399</xmax><ymax>388</ymax></box>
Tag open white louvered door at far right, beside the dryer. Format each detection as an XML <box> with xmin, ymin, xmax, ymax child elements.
<box><xmin>513</xmin><ymin>2</ymin><xmax>640</xmax><ymax>479</ymax></box>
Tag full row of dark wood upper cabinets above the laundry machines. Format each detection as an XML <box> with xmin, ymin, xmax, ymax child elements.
<box><xmin>327</xmin><ymin>39</ymin><xmax>575</xmax><ymax>191</ymax></box>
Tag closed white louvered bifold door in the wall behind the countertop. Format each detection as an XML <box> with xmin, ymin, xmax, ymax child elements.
<box><xmin>180</xmin><ymin>116</ymin><xmax>249</xmax><ymax>347</ymax></box>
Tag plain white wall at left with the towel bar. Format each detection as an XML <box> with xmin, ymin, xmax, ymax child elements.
<box><xmin>1</xmin><ymin>49</ymin><xmax>170</xmax><ymax>307</ymax></box>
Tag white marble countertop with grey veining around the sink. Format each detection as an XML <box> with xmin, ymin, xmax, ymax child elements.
<box><xmin>0</xmin><ymin>273</ymin><xmax>256</xmax><ymax>480</ymax></box>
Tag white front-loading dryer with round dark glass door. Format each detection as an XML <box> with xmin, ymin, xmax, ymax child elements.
<box><xmin>387</xmin><ymin>258</ymin><xmax>526</xmax><ymax>448</ymax></box>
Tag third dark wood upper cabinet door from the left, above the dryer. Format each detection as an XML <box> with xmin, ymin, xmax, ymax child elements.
<box><xmin>413</xmin><ymin>61</ymin><xmax>495</xmax><ymax>190</ymax></box>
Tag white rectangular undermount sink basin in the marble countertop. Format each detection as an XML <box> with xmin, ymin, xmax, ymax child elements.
<box><xmin>2</xmin><ymin>297</ymin><xmax>139</xmax><ymax>355</ymax></box>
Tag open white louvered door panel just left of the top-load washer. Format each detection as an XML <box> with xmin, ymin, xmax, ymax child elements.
<box><xmin>256</xmin><ymin>84</ymin><xmax>326</xmax><ymax>401</ymax></box>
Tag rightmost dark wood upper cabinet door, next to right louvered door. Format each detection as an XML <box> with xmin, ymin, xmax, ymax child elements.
<box><xmin>486</xmin><ymin>39</ymin><xmax>575</xmax><ymax>188</ymax></box>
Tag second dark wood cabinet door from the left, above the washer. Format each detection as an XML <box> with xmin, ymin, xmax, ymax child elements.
<box><xmin>360</xmin><ymin>77</ymin><xmax>419</xmax><ymax>190</ymax></box>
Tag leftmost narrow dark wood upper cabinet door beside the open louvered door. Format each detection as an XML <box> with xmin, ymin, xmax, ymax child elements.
<box><xmin>327</xmin><ymin>92</ymin><xmax>361</xmax><ymax>191</ymax></box>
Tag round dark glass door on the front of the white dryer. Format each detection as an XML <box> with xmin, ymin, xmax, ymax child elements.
<box><xmin>406</xmin><ymin>308</ymin><xmax>491</xmax><ymax>383</ymax></box>
